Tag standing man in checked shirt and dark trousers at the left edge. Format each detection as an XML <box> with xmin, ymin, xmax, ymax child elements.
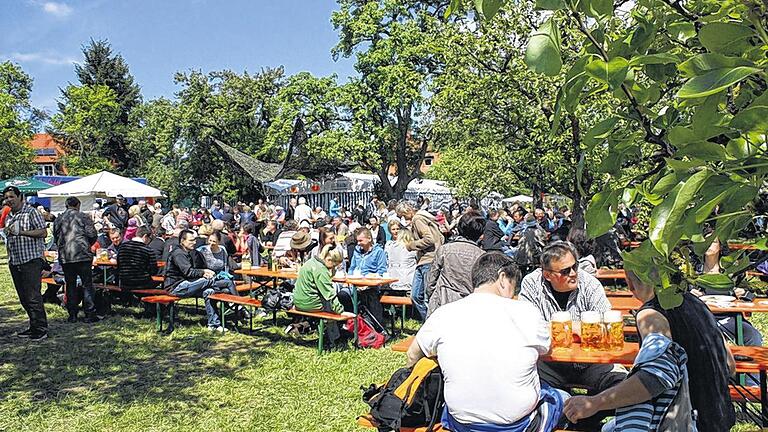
<box><xmin>3</xmin><ymin>186</ymin><xmax>48</xmax><ymax>340</ymax></box>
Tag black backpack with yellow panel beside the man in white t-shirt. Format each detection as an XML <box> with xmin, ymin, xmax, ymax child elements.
<box><xmin>362</xmin><ymin>357</ymin><xmax>445</xmax><ymax>432</ymax></box>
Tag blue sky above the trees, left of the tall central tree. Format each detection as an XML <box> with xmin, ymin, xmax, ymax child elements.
<box><xmin>0</xmin><ymin>0</ymin><xmax>353</xmax><ymax>114</ymax></box>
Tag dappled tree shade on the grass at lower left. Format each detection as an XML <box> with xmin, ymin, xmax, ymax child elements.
<box><xmin>0</xmin><ymin>298</ymin><xmax>270</xmax><ymax>416</ymax></box>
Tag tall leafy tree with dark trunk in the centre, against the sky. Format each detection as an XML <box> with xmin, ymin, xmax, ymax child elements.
<box><xmin>325</xmin><ymin>0</ymin><xmax>444</xmax><ymax>198</ymax></box>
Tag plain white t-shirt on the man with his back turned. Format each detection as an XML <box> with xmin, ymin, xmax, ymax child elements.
<box><xmin>416</xmin><ymin>293</ymin><xmax>550</xmax><ymax>425</ymax></box>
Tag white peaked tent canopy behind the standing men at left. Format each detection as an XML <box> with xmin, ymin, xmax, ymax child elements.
<box><xmin>37</xmin><ymin>171</ymin><xmax>163</xmax><ymax>213</ymax></box>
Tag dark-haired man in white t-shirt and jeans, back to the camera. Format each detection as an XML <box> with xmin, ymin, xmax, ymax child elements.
<box><xmin>408</xmin><ymin>252</ymin><xmax>567</xmax><ymax>432</ymax></box>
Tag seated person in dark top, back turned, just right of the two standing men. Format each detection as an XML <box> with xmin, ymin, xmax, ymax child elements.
<box><xmin>117</xmin><ymin>226</ymin><xmax>158</xmax><ymax>291</ymax></box>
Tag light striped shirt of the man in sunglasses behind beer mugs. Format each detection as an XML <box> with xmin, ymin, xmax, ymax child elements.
<box><xmin>520</xmin><ymin>268</ymin><xmax>611</xmax><ymax>322</ymax></box>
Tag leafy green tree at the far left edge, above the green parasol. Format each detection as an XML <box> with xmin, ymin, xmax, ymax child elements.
<box><xmin>0</xmin><ymin>61</ymin><xmax>36</xmax><ymax>178</ymax></box>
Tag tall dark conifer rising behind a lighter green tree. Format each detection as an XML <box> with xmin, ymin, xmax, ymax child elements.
<box><xmin>72</xmin><ymin>40</ymin><xmax>141</xmax><ymax>174</ymax></box>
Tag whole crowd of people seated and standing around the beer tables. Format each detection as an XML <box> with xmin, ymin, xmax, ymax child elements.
<box><xmin>3</xmin><ymin>187</ymin><xmax>759</xmax><ymax>431</ymax></box>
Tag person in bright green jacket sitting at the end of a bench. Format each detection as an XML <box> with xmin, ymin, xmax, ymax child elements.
<box><xmin>293</xmin><ymin>245</ymin><xmax>354</xmax><ymax>344</ymax></box>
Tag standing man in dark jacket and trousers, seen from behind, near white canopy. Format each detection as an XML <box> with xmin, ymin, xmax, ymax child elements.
<box><xmin>53</xmin><ymin>197</ymin><xmax>98</xmax><ymax>323</ymax></box>
